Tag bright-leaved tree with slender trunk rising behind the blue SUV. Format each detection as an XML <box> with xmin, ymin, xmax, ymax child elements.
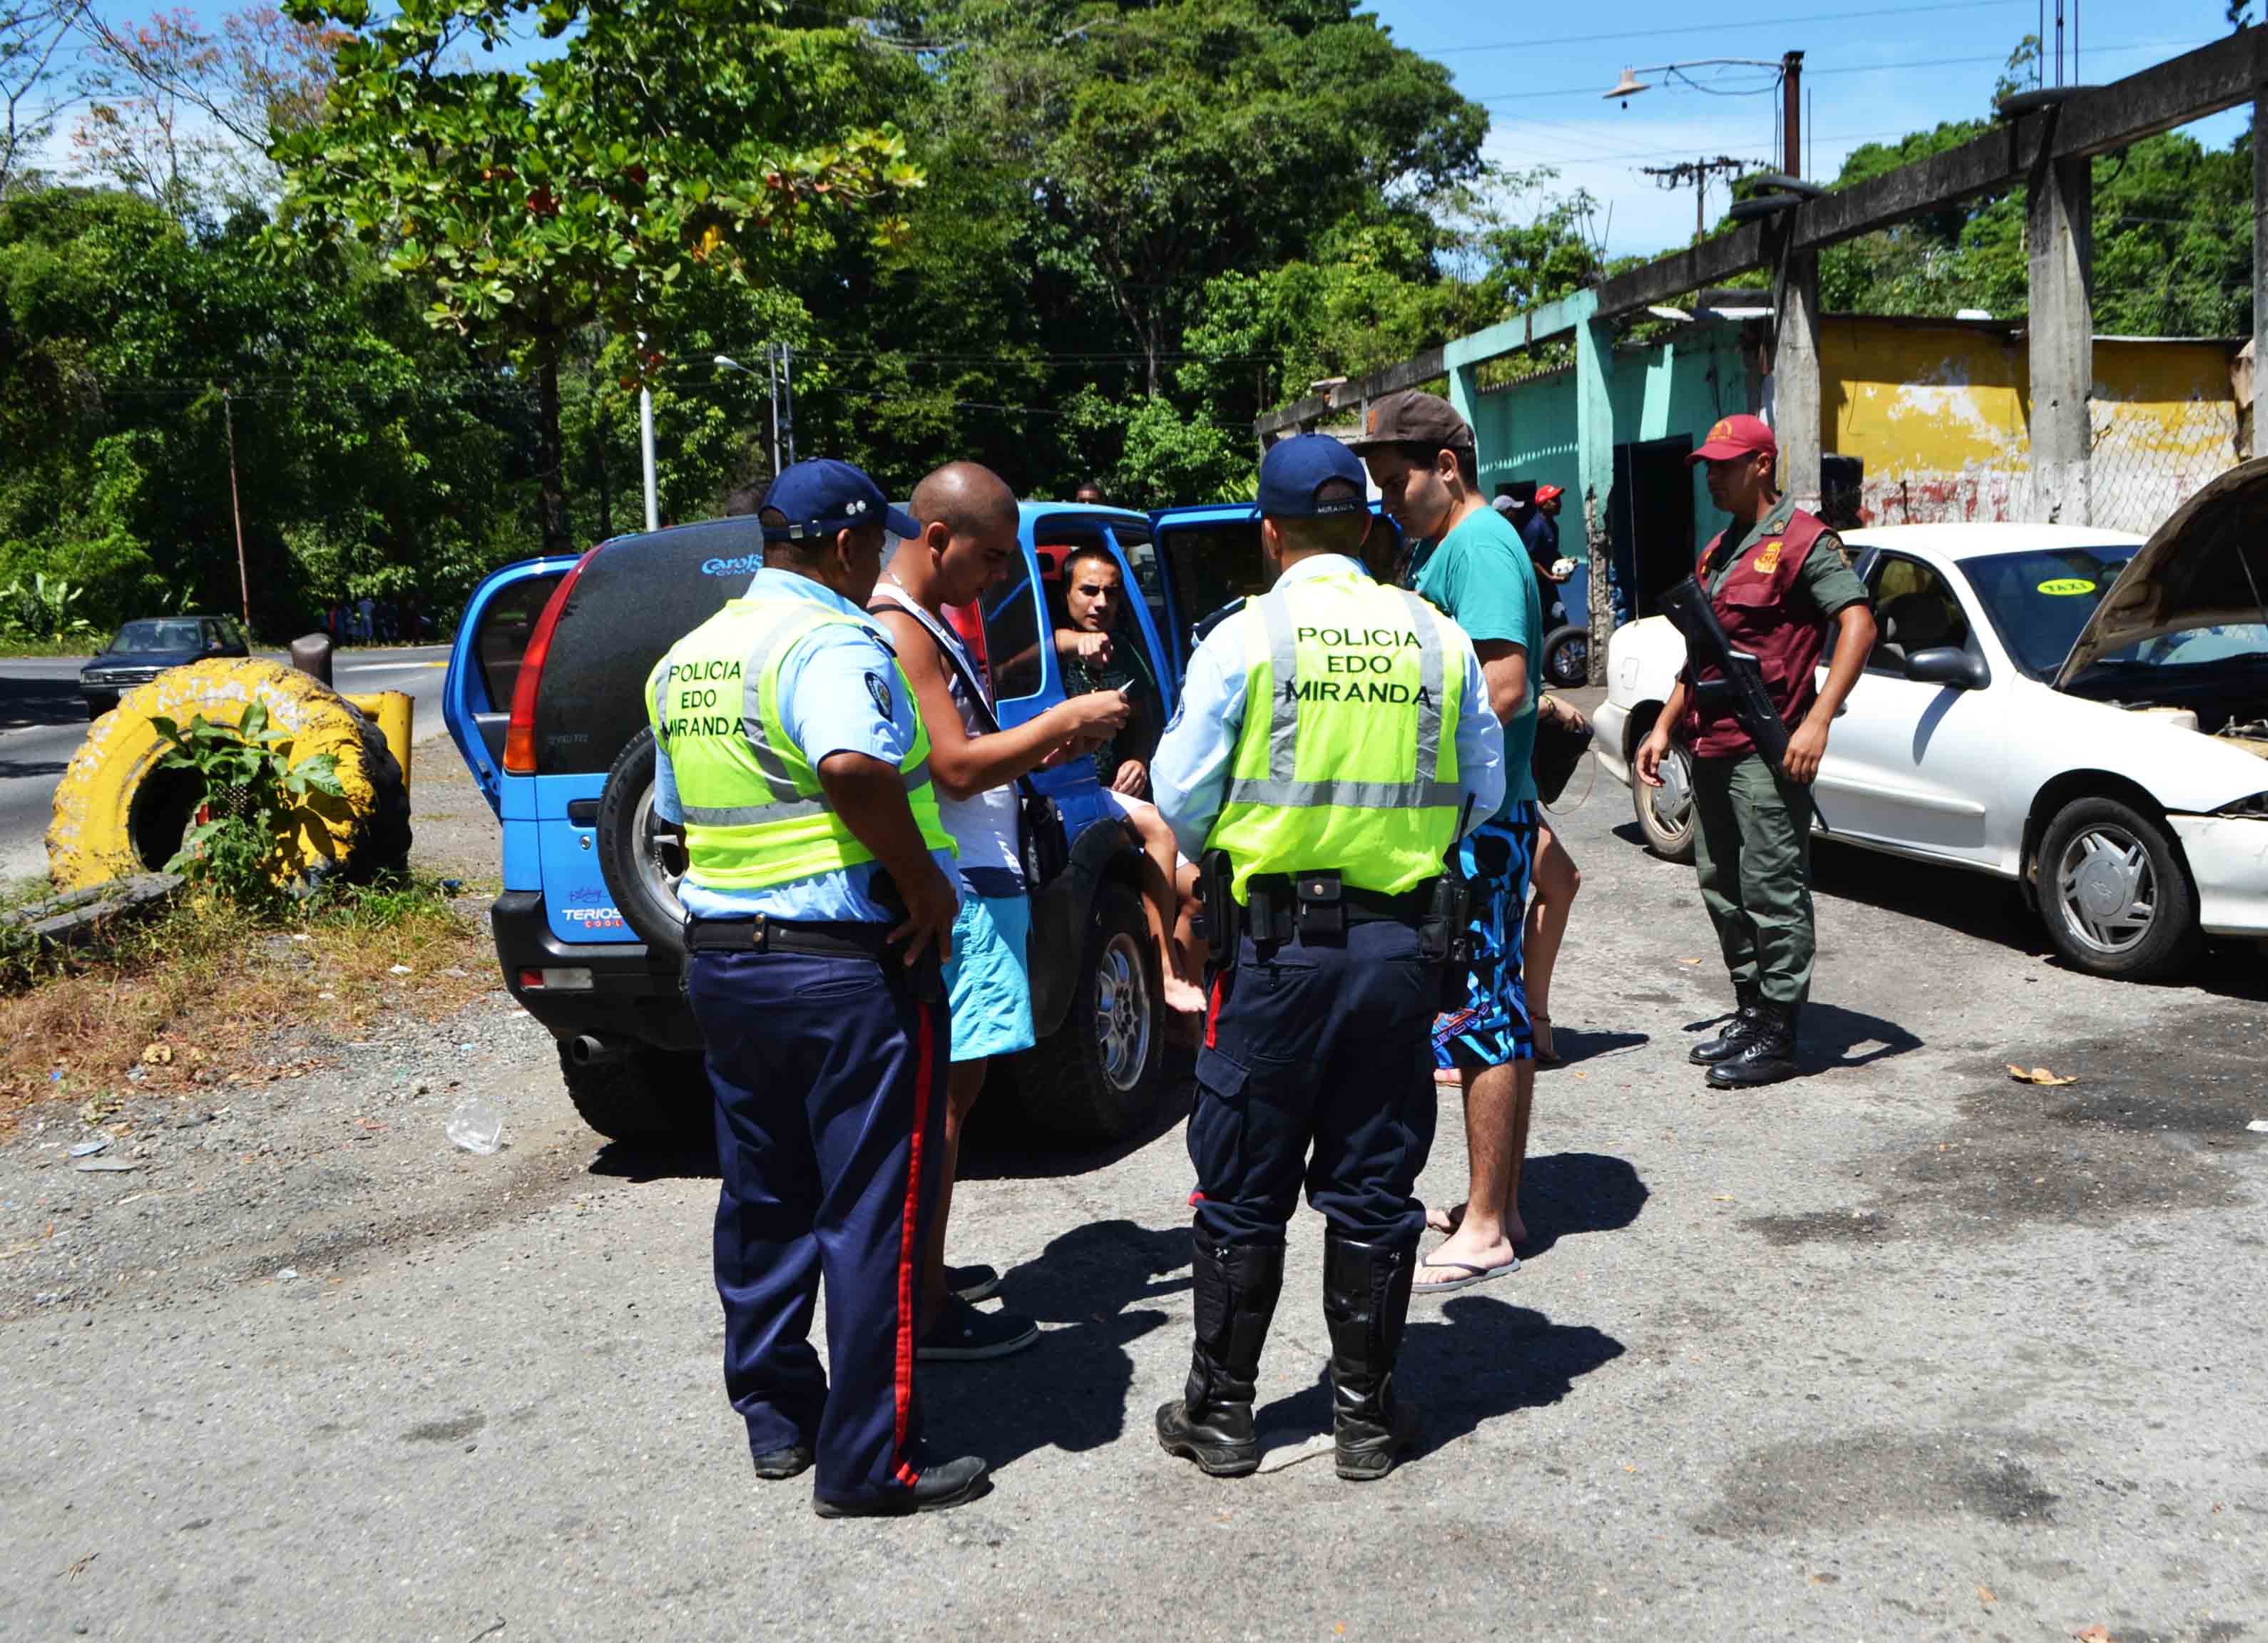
<box><xmin>277</xmin><ymin>0</ymin><xmax>921</xmax><ymax>551</ymax></box>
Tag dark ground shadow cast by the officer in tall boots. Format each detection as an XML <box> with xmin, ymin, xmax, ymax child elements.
<box><xmin>1255</xmin><ymin>1294</ymin><xmax>1624</xmax><ymax>1462</ymax></box>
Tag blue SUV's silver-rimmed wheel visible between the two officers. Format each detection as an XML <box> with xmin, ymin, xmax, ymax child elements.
<box><xmin>1016</xmin><ymin>879</ymin><xmax>1166</xmax><ymax>1142</ymax></box>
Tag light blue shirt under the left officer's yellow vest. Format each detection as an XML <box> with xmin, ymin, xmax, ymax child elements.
<box><xmin>653</xmin><ymin>571</ymin><xmax>959</xmax><ymax>925</ymax></box>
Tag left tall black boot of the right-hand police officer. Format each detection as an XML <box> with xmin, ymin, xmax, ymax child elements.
<box><xmin>1157</xmin><ymin>1233</ymin><xmax>1284</xmax><ymax>1478</ymax></box>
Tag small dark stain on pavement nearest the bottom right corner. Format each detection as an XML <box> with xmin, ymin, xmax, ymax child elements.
<box><xmin>1694</xmin><ymin>1430</ymin><xmax>2059</xmax><ymax>1537</ymax></box>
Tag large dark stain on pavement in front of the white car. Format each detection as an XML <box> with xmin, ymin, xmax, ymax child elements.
<box><xmin>1744</xmin><ymin>1010</ymin><xmax>2268</xmax><ymax>1247</ymax></box>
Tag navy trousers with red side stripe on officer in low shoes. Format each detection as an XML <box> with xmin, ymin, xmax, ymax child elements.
<box><xmin>685</xmin><ymin>952</ymin><xmax>953</xmax><ymax>1503</ymax></box>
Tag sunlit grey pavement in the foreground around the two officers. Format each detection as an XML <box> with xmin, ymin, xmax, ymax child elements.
<box><xmin>0</xmin><ymin>730</ymin><xmax>2268</xmax><ymax>1643</ymax></box>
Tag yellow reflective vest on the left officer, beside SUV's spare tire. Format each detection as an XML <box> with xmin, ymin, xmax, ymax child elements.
<box><xmin>646</xmin><ymin>598</ymin><xmax>955</xmax><ymax>891</ymax></box>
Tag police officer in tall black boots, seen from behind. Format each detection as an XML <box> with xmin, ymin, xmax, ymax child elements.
<box><xmin>1150</xmin><ymin>435</ymin><xmax>1503</xmax><ymax>1480</ymax></box>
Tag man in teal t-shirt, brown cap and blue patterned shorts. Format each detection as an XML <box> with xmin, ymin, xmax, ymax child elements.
<box><xmin>1352</xmin><ymin>392</ymin><xmax>1545</xmax><ymax>1294</ymax></box>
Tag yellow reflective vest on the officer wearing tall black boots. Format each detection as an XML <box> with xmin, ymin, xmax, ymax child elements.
<box><xmin>1207</xmin><ymin>571</ymin><xmax>1470</xmax><ymax>902</ymax></box>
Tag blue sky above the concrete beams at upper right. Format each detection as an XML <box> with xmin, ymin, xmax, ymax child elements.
<box><xmin>1370</xmin><ymin>0</ymin><xmax>2245</xmax><ymax>254</ymax></box>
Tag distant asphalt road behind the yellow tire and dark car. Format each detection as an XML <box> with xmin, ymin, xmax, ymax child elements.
<box><xmin>0</xmin><ymin>644</ymin><xmax>449</xmax><ymax>884</ymax></box>
